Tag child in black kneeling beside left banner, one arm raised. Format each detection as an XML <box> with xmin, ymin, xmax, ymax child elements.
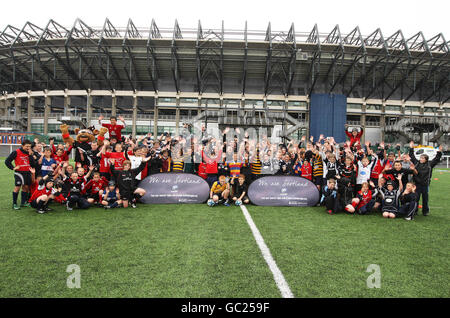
<box><xmin>110</xmin><ymin>157</ymin><xmax>150</xmax><ymax>208</ymax></box>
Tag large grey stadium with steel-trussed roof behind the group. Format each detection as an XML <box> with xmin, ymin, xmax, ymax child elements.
<box><xmin>0</xmin><ymin>19</ymin><xmax>450</xmax><ymax>143</ymax></box>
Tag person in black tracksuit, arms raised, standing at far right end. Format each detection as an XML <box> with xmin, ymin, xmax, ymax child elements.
<box><xmin>409</xmin><ymin>141</ymin><xmax>442</xmax><ymax>216</ymax></box>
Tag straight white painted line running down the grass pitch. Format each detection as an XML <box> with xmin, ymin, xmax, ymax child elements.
<box><xmin>241</xmin><ymin>205</ymin><xmax>294</xmax><ymax>298</ymax></box>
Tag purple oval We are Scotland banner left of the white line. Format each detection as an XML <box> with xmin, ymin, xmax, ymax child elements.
<box><xmin>139</xmin><ymin>173</ymin><xmax>209</xmax><ymax>204</ymax></box>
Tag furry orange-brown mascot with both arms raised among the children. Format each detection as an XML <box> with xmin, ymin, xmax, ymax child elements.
<box><xmin>60</xmin><ymin>124</ymin><xmax>108</xmax><ymax>166</ymax></box>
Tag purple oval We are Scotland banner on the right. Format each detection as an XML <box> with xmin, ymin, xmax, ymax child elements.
<box><xmin>248</xmin><ymin>176</ymin><xmax>319</xmax><ymax>206</ymax></box>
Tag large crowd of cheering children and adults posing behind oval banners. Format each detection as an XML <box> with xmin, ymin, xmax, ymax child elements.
<box><xmin>5</xmin><ymin>117</ymin><xmax>442</xmax><ymax>220</ymax></box>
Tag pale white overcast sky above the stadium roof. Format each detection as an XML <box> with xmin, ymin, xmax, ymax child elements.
<box><xmin>0</xmin><ymin>0</ymin><xmax>450</xmax><ymax>41</ymax></box>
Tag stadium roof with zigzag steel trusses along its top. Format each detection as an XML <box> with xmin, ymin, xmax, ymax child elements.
<box><xmin>0</xmin><ymin>19</ymin><xmax>450</xmax><ymax>103</ymax></box>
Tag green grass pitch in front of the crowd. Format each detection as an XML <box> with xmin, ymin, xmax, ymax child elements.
<box><xmin>0</xmin><ymin>160</ymin><xmax>450</xmax><ymax>297</ymax></box>
